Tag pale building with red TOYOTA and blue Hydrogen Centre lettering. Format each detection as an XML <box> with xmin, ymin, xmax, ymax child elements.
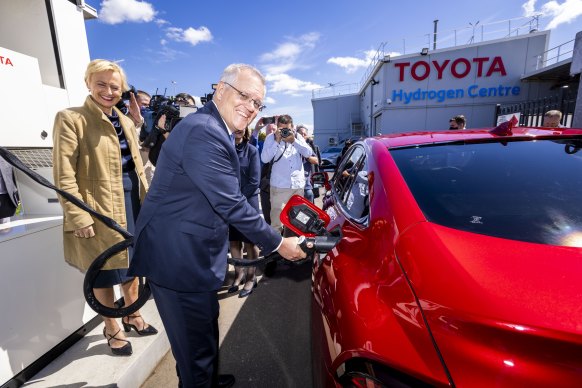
<box><xmin>312</xmin><ymin>31</ymin><xmax>579</xmax><ymax>147</ymax></box>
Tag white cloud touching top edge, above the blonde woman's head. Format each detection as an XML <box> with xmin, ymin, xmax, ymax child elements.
<box><xmin>99</xmin><ymin>0</ymin><xmax>156</xmax><ymax>24</ymax></box>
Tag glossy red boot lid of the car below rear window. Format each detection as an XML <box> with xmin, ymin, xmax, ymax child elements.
<box><xmin>396</xmin><ymin>222</ymin><xmax>582</xmax><ymax>386</ymax></box>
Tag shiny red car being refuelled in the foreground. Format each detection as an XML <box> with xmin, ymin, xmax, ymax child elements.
<box><xmin>312</xmin><ymin>126</ymin><xmax>582</xmax><ymax>387</ymax></box>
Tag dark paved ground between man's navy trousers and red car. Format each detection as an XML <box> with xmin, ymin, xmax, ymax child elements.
<box><xmin>142</xmin><ymin>263</ymin><xmax>311</xmax><ymax>388</ymax></box>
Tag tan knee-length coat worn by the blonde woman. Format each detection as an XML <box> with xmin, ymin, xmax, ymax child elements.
<box><xmin>53</xmin><ymin>96</ymin><xmax>147</xmax><ymax>271</ymax></box>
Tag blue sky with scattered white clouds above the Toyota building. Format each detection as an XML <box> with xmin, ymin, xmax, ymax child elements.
<box><xmin>86</xmin><ymin>0</ymin><xmax>582</xmax><ymax>129</ymax></box>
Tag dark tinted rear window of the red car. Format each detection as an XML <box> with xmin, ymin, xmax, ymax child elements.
<box><xmin>390</xmin><ymin>138</ymin><xmax>582</xmax><ymax>247</ymax></box>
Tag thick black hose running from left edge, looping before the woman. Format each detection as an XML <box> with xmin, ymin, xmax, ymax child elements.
<box><xmin>0</xmin><ymin>147</ymin><xmax>151</xmax><ymax>318</ymax></box>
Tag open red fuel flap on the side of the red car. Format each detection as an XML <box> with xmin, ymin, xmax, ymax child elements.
<box><xmin>280</xmin><ymin>195</ymin><xmax>330</xmax><ymax>237</ymax></box>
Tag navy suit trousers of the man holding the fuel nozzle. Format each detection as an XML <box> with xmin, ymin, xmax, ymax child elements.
<box><xmin>149</xmin><ymin>281</ymin><xmax>219</xmax><ymax>388</ymax></box>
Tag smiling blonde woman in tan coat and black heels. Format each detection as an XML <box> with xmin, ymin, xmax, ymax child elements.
<box><xmin>53</xmin><ymin>59</ymin><xmax>157</xmax><ymax>356</ymax></box>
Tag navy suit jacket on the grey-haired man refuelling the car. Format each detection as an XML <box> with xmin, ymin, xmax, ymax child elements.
<box><xmin>128</xmin><ymin>102</ymin><xmax>282</xmax><ymax>292</ymax></box>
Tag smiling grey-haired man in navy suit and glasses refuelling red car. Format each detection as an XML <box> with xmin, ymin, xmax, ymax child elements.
<box><xmin>129</xmin><ymin>64</ymin><xmax>305</xmax><ymax>387</ymax></box>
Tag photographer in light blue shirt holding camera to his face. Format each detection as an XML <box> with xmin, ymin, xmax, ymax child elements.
<box><xmin>261</xmin><ymin>115</ymin><xmax>313</xmax><ymax>236</ymax></box>
